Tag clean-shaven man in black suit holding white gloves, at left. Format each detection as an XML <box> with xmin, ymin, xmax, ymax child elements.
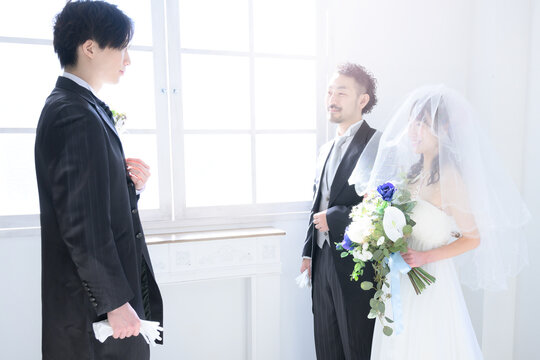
<box><xmin>35</xmin><ymin>1</ymin><xmax>163</xmax><ymax>360</ymax></box>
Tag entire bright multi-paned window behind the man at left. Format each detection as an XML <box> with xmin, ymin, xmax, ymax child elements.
<box><xmin>0</xmin><ymin>0</ymin><xmax>325</xmax><ymax>228</ymax></box>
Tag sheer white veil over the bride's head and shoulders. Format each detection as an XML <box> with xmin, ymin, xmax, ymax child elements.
<box><xmin>349</xmin><ymin>85</ymin><xmax>530</xmax><ymax>290</ymax></box>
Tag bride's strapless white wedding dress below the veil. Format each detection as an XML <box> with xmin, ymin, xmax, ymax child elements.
<box><xmin>371</xmin><ymin>200</ymin><xmax>482</xmax><ymax>360</ymax></box>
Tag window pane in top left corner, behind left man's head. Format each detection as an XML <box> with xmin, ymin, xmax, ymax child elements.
<box><xmin>0</xmin><ymin>0</ymin><xmax>66</xmax><ymax>39</ymax></box>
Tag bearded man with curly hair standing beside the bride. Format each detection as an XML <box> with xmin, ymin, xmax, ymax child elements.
<box><xmin>300</xmin><ymin>63</ymin><xmax>377</xmax><ymax>360</ymax></box>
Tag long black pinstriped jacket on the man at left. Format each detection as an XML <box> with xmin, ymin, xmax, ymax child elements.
<box><xmin>35</xmin><ymin>77</ymin><xmax>163</xmax><ymax>360</ymax></box>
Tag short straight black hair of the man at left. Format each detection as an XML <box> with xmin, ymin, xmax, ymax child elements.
<box><xmin>53</xmin><ymin>0</ymin><xmax>133</xmax><ymax>67</ymax></box>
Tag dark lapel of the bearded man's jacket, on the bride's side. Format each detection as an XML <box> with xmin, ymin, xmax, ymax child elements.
<box><xmin>329</xmin><ymin>121</ymin><xmax>373</xmax><ymax>204</ymax></box>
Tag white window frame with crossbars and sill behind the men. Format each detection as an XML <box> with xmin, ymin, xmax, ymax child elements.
<box><xmin>0</xmin><ymin>0</ymin><xmax>329</xmax><ymax>231</ymax></box>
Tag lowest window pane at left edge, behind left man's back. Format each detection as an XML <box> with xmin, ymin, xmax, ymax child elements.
<box><xmin>0</xmin><ymin>134</ymin><xmax>39</xmax><ymax>216</ymax></box>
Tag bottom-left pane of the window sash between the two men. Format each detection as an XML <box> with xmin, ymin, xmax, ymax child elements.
<box><xmin>185</xmin><ymin>135</ymin><xmax>252</xmax><ymax>207</ymax></box>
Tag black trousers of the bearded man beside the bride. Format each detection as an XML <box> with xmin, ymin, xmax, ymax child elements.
<box><xmin>312</xmin><ymin>242</ymin><xmax>374</xmax><ymax>360</ymax></box>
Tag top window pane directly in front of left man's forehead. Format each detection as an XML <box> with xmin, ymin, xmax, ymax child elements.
<box><xmin>107</xmin><ymin>0</ymin><xmax>152</xmax><ymax>45</ymax></box>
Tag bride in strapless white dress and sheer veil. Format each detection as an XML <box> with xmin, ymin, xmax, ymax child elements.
<box><xmin>349</xmin><ymin>85</ymin><xmax>529</xmax><ymax>360</ymax></box>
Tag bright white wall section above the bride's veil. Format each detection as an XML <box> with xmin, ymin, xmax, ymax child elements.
<box><xmin>329</xmin><ymin>0</ymin><xmax>472</xmax><ymax>129</ymax></box>
